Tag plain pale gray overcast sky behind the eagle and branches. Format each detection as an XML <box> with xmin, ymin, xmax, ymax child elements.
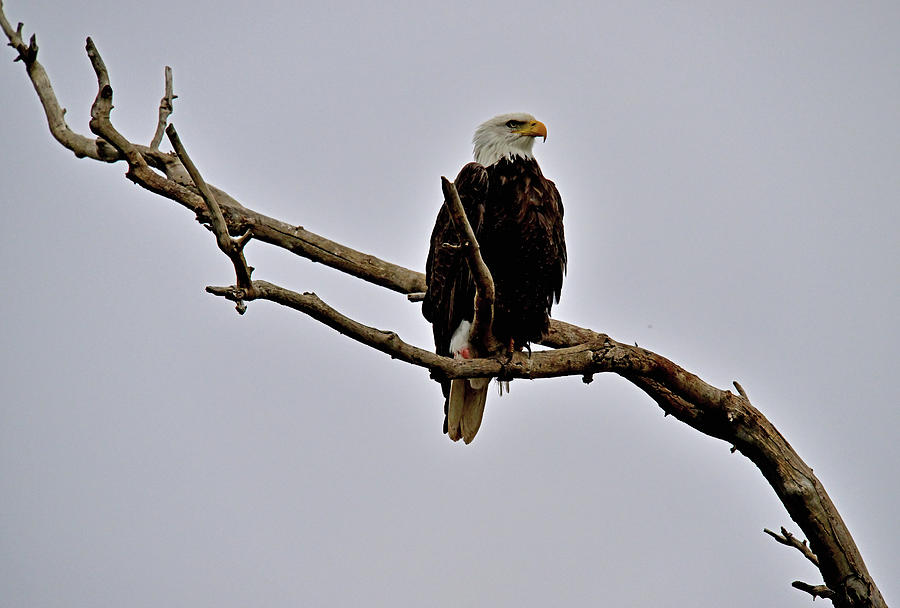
<box><xmin>0</xmin><ymin>0</ymin><xmax>900</xmax><ymax>607</ymax></box>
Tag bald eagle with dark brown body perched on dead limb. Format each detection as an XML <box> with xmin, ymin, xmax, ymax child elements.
<box><xmin>422</xmin><ymin>113</ymin><xmax>566</xmax><ymax>443</ymax></box>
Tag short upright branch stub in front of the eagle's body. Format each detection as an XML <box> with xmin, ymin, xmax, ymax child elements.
<box><xmin>441</xmin><ymin>177</ymin><xmax>500</xmax><ymax>355</ymax></box>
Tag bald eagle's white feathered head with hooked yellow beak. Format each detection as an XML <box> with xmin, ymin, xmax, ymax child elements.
<box><xmin>472</xmin><ymin>112</ymin><xmax>547</xmax><ymax>167</ymax></box>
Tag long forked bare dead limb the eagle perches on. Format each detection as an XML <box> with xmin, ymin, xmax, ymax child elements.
<box><xmin>0</xmin><ymin>5</ymin><xmax>886</xmax><ymax>608</ymax></box>
